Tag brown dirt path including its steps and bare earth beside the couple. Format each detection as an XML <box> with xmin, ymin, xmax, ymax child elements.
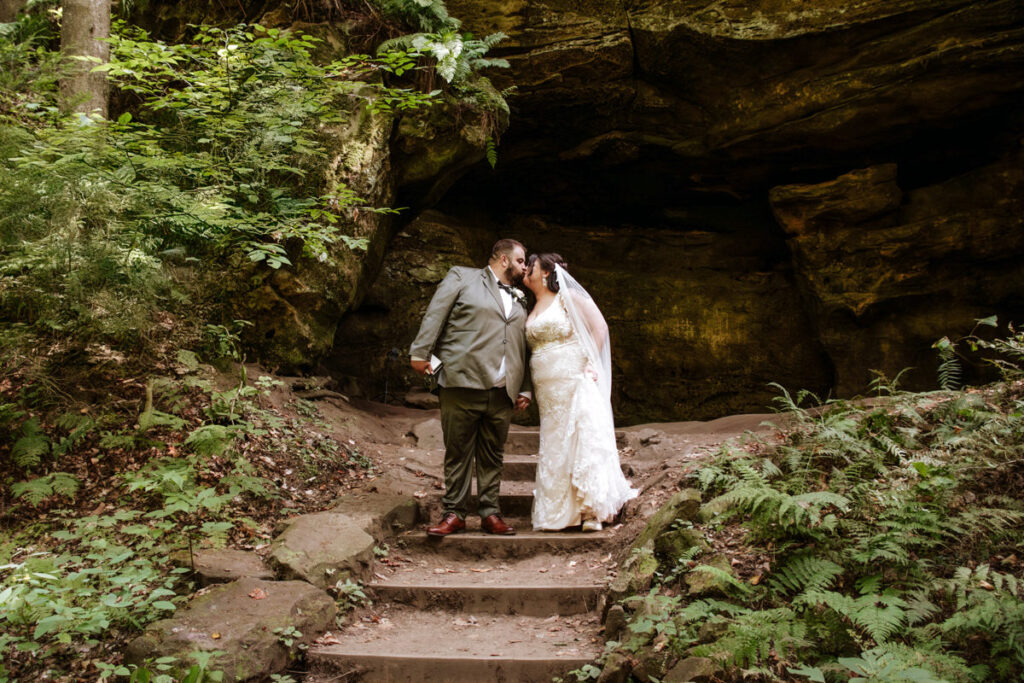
<box><xmin>299</xmin><ymin>404</ymin><xmax>769</xmax><ymax>683</ymax></box>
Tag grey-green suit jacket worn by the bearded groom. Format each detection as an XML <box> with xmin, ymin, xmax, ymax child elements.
<box><xmin>410</xmin><ymin>265</ymin><xmax>531</xmax><ymax>401</ymax></box>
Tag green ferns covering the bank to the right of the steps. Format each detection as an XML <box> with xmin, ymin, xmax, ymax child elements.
<box><xmin>618</xmin><ymin>331</ymin><xmax>1024</xmax><ymax>682</ymax></box>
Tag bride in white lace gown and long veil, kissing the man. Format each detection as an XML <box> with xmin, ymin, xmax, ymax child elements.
<box><xmin>523</xmin><ymin>254</ymin><xmax>638</xmax><ymax>531</ymax></box>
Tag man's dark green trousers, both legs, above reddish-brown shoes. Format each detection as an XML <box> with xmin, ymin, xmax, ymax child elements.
<box><xmin>438</xmin><ymin>387</ymin><xmax>512</xmax><ymax>519</ymax></box>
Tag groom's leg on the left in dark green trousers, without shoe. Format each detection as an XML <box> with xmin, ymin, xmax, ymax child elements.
<box><xmin>438</xmin><ymin>387</ymin><xmax>487</xmax><ymax>519</ymax></box>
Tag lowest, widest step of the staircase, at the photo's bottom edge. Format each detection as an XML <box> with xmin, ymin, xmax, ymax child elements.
<box><xmin>307</xmin><ymin>610</ymin><xmax>603</xmax><ymax>683</ymax></box>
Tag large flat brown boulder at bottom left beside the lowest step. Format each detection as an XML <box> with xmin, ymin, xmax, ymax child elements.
<box><xmin>125</xmin><ymin>578</ymin><xmax>337</xmax><ymax>683</ymax></box>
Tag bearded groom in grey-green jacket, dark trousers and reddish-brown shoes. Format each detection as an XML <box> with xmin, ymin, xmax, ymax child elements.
<box><xmin>410</xmin><ymin>240</ymin><xmax>530</xmax><ymax>536</ymax></box>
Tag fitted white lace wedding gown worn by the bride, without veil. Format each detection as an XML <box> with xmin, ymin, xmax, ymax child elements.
<box><xmin>526</xmin><ymin>293</ymin><xmax>638</xmax><ymax>529</ymax></box>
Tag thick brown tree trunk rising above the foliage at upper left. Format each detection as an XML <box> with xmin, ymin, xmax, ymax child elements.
<box><xmin>58</xmin><ymin>0</ymin><xmax>111</xmax><ymax>119</ymax></box>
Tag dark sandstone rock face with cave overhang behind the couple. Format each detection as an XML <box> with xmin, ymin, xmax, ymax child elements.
<box><xmin>147</xmin><ymin>0</ymin><xmax>1024</xmax><ymax>423</ymax></box>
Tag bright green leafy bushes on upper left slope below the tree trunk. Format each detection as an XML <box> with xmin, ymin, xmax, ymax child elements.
<box><xmin>0</xmin><ymin>18</ymin><xmax>436</xmax><ymax>346</ymax></box>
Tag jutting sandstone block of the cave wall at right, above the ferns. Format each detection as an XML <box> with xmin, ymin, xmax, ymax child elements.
<box><xmin>770</xmin><ymin>154</ymin><xmax>1024</xmax><ymax>395</ymax></box>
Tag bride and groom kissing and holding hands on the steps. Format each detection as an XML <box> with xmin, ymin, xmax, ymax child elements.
<box><xmin>410</xmin><ymin>240</ymin><xmax>638</xmax><ymax>537</ymax></box>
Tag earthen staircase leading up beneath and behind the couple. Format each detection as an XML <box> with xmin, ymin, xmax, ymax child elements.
<box><xmin>309</xmin><ymin>430</ymin><xmax>614</xmax><ymax>683</ymax></box>
